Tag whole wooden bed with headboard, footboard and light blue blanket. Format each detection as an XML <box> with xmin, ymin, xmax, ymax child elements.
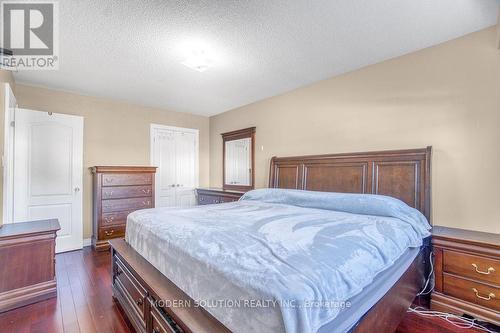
<box><xmin>111</xmin><ymin>148</ymin><xmax>431</xmax><ymax>333</ymax></box>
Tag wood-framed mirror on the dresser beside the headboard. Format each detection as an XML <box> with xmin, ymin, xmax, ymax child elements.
<box><xmin>221</xmin><ymin>127</ymin><xmax>255</xmax><ymax>191</ymax></box>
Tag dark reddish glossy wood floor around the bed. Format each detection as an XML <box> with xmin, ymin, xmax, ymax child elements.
<box><xmin>0</xmin><ymin>248</ymin><xmax>492</xmax><ymax>333</ymax></box>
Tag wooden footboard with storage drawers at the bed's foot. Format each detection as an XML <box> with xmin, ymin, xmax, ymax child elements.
<box><xmin>109</xmin><ymin>238</ymin><xmax>231</xmax><ymax>333</ymax></box>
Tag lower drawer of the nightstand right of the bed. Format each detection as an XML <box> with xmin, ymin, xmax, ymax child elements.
<box><xmin>443</xmin><ymin>273</ymin><xmax>500</xmax><ymax>311</ymax></box>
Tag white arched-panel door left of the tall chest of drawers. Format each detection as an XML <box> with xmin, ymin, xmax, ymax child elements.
<box><xmin>14</xmin><ymin>109</ymin><xmax>83</xmax><ymax>252</ymax></box>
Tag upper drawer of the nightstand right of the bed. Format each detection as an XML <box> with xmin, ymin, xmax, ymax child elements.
<box><xmin>443</xmin><ymin>250</ymin><xmax>500</xmax><ymax>286</ymax></box>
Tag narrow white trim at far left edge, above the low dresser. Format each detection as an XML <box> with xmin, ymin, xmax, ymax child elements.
<box><xmin>2</xmin><ymin>83</ymin><xmax>17</xmax><ymax>224</ymax></box>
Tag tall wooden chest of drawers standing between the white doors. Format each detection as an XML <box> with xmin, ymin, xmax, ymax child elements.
<box><xmin>91</xmin><ymin>166</ymin><xmax>156</xmax><ymax>251</ymax></box>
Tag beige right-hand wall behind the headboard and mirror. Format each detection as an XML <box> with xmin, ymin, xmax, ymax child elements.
<box><xmin>210</xmin><ymin>27</ymin><xmax>500</xmax><ymax>233</ymax></box>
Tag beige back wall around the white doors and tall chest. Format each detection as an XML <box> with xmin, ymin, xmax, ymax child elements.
<box><xmin>15</xmin><ymin>84</ymin><xmax>209</xmax><ymax>238</ymax></box>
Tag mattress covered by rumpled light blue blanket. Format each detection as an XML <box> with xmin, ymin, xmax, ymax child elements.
<box><xmin>126</xmin><ymin>190</ymin><xmax>429</xmax><ymax>333</ymax></box>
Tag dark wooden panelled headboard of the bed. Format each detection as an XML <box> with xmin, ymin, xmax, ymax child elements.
<box><xmin>269</xmin><ymin>147</ymin><xmax>431</xmax><ymax>222</ymax></box>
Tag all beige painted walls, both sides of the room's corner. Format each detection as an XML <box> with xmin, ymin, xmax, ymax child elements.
<box><xmin>0</xmin><ymin>27</ymin><xmax>500</xmax><ymax>238</ymax></box>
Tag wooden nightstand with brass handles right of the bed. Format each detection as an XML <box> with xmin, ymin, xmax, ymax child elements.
<box><xmin>431</xmin><ymin>226</ymin><xmax>500</xmax><ymax>325</ymax></box>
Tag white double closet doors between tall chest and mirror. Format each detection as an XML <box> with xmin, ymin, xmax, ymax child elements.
<box><xmin>151</xmin><ymin>125</ymin><xmax>198</xmax><ymax>207</ymax></box>
